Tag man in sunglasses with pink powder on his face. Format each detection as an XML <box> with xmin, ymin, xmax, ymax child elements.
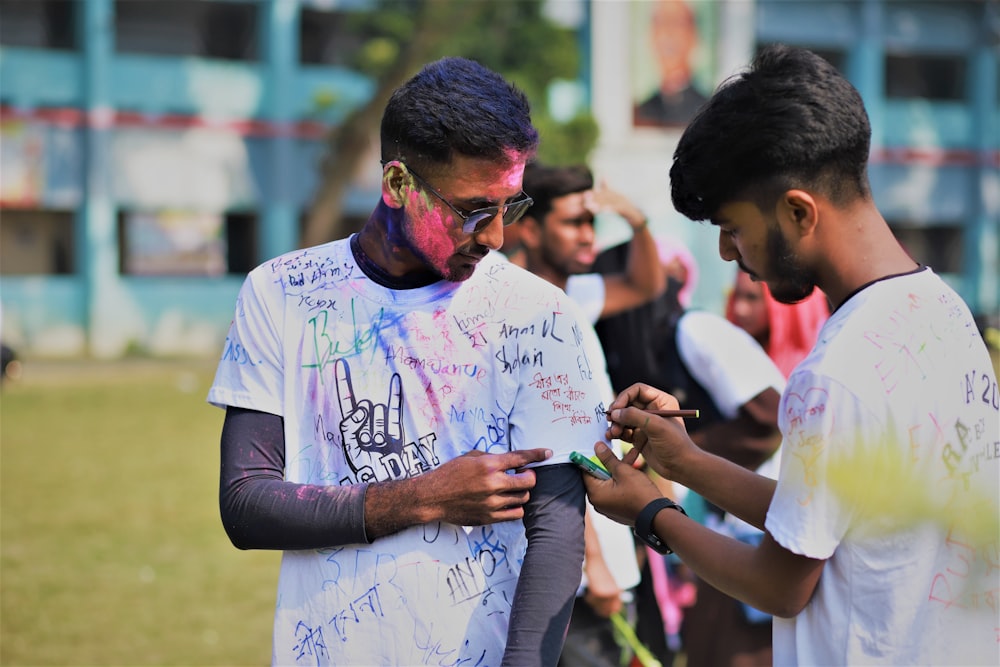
<box><xmin>208</xmin><ymin>58</ymin><xmax>610</xmax><ymax>666</ymax></box>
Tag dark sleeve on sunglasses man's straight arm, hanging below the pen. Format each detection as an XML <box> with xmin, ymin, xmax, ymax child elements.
<box><xmin>502</xmin><ymin>464</ymin><xmax>586</xmax><ymax>667</ymax></box>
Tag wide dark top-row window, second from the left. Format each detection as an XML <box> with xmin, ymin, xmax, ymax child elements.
<box><xmin>115</xmin><ymin>0</ymin><xmax>258</xmax><ymax>60</ymax></box>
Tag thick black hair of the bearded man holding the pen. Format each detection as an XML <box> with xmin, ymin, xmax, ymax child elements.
<box><xmin>670</xmin><ymin>44</ymin><xmax>871</xmax><ymax>220</ymax></box>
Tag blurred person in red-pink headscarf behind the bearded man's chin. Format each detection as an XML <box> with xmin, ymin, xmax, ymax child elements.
<box><xmin>726</xmin><ymin>269</ymin><xmax>830</xmax><ymax>378</ymax></box>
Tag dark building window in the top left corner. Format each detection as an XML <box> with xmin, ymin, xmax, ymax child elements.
<box><xmin>0</xmin><ymin>0</ymin><xmax>82</xmax><ymax>50</ymax></box>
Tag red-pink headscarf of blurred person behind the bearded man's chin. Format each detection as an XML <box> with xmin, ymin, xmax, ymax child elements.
<box><xmin>726</xmin><ymin>282</ymin><xmax>830</xmax><ymax>378</ymax></box>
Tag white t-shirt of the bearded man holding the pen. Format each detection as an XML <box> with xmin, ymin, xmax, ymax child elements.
<box><xmin>766</xmin><ymin>269</ymin><xmax>1000</xmax><ymax>665</ymax></box>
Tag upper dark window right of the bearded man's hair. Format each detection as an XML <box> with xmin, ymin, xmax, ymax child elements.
<box><xmin>885</xmin><ymin>53</ymin><xmax>967</xmax><ymax>100</ymax></box>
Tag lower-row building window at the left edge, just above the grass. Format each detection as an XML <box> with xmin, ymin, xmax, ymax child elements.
<box><xmin>0</xmin><ymin>208</ymin><xmax>75</xmax><ymax>275</ymax></box>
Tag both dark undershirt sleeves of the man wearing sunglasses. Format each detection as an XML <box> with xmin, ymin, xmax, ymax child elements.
<box><xmin>219</xmin><ymin>407</ymin><xmax>585</xmax><ymax>667</ymax></box>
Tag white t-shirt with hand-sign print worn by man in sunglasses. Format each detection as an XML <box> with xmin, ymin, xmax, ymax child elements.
<box><xmin>209</xmin><ymin>240</ymin><xmax>607</xmax><ymax>666</ymax></box>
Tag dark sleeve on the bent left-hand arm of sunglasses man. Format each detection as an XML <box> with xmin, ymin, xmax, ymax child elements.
<box><xmin>219</xmin><ymin>407</ymin><xmax>368</xmax><ymax>549</ymax></box>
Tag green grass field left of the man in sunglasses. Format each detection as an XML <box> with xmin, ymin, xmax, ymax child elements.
<box><xmin>0</xmin><ymin>361</ymin><xmax>279</xmax><ymax>666</ymax></box>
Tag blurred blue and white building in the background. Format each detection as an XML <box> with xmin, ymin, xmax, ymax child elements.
<box><xmin>0</xmin><ymin>0</ymin><xmax>1000</xmax><ymax>357</ymax></box>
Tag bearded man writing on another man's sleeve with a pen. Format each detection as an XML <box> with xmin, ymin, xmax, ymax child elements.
<box><xmin>585</xmin><ymin>45</ymin><xmax>1000</xmax><ymax>665</ymax></box>
